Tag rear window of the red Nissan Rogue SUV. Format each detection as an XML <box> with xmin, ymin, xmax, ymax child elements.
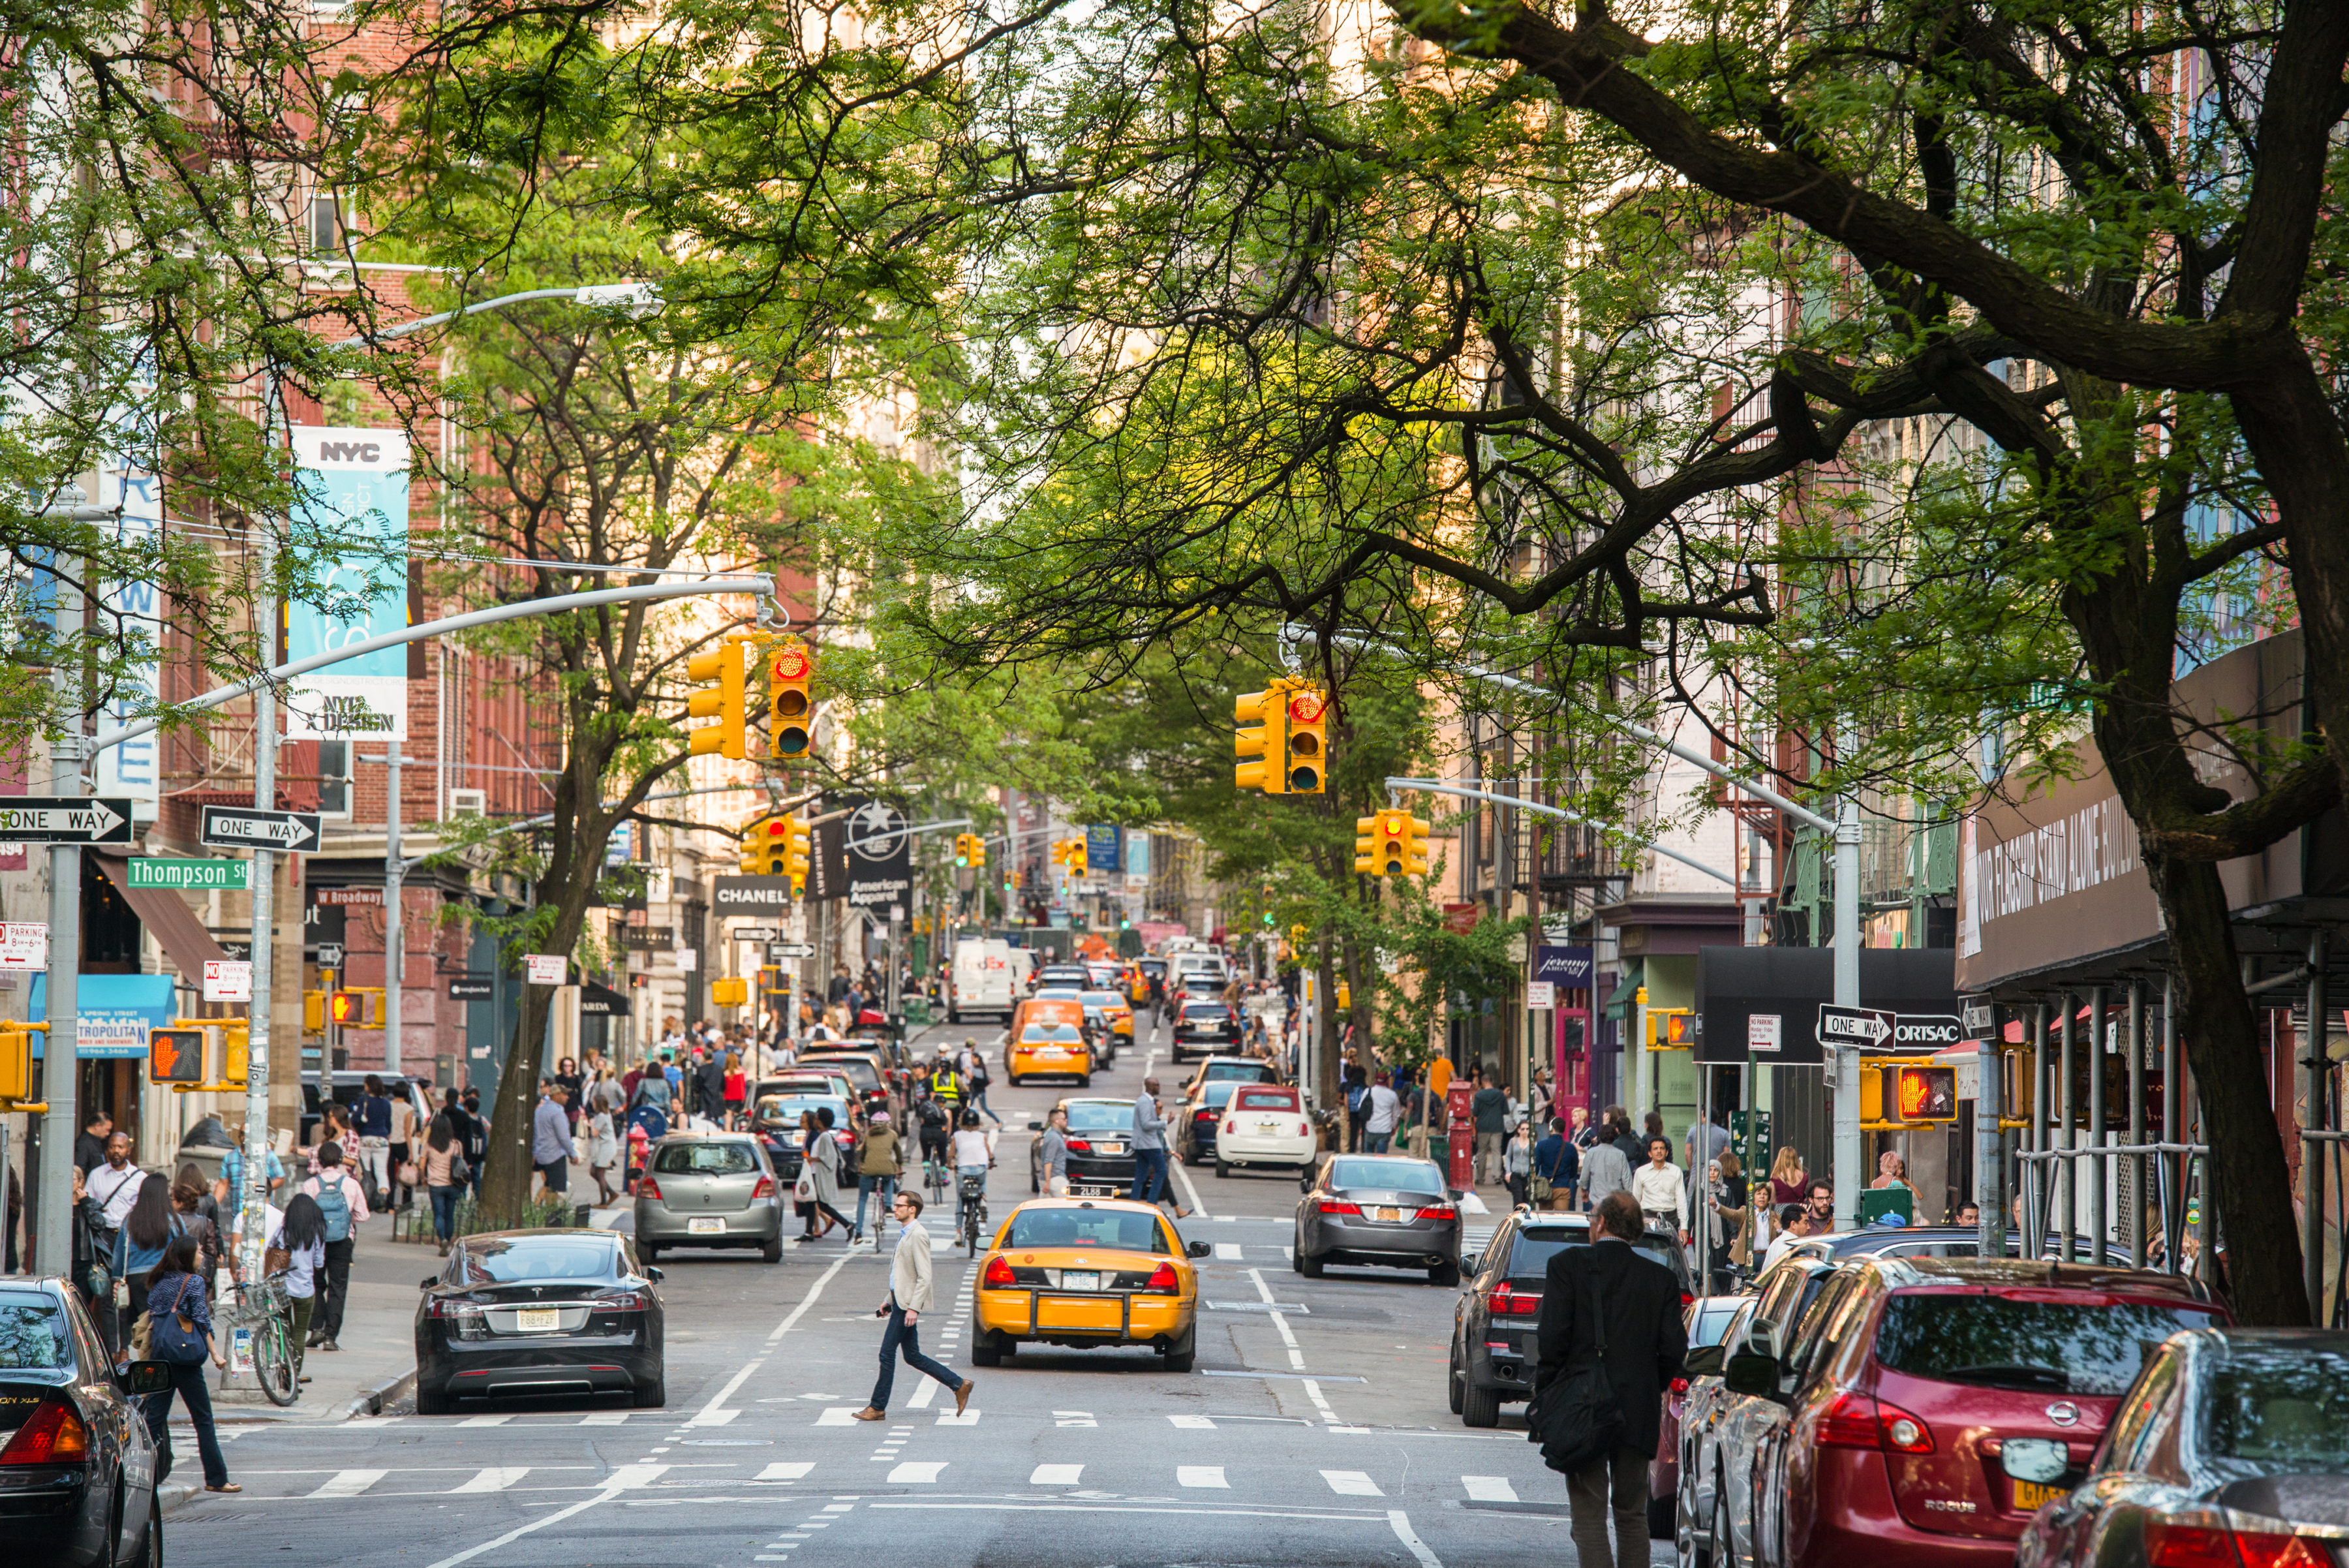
<box><xmin>1877</xmin><ymin>1293</ymin><xmax>2215</xmax><ymax>1394</ymax></box>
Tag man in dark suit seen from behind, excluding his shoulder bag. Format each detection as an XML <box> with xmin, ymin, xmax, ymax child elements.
<box><xmin>1534</xmin><ymin>1192</ymin><xmax>1689</xmax><ymax>1568</ymax></box>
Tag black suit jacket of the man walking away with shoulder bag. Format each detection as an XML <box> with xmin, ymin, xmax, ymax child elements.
<box><xmin>1534</xmin><ymin>1239</ymin><xmax>1689</xmax><ymax>1453</ymax></box>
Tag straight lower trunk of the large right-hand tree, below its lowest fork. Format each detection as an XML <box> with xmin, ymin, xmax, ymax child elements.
<box><xmin>2142</xmin><ymin>854</ymin><xmax>2309</xmax><ymax>1326</ymax></box>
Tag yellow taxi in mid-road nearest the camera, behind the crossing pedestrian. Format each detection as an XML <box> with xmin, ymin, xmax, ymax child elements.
<box><xmin>970</xmin><ymin>1197</ymin><xmax>1210</xmax><ymax>1371</ymax></box>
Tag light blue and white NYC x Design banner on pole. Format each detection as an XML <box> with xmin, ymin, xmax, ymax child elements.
<box><xmin>282</xmin><ymin>425</ymin><xmax>408</xmax><ymax>739</ymax></box>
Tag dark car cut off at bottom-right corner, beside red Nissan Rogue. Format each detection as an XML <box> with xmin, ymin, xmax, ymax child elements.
<box><xmin>1997</xmin><ymin>1329</ymin><xmax>2349</xmax><ymax>1568</ymax></box>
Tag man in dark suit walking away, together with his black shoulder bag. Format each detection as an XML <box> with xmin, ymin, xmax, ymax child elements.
<box><xmin>1524</xmin><ymin>1192</ymin><xmax>1689</xmax><ymax>1568</ymax></box>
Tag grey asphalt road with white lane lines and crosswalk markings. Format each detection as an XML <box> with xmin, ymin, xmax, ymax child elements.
<box><xmin>167</xmin><ymin>1026</ymin><xmax>1670</xmax><ymax>1568</ymax></box>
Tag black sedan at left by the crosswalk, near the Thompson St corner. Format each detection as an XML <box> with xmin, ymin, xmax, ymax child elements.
<box><xmin>416</xmin><ymin>1230</ymin><xmax>667</xmax><ymax>1415</ymax></box>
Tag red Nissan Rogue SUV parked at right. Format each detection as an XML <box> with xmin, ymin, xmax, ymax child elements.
<box><xmin>1706</xmin><ymin>1258</ymin><xmax>2227</xmax><ymax>1568</ymax></box>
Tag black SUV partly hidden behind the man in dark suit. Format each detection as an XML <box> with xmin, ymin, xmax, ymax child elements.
<box><xmin>1447</xmin><ymin>1211</ymin><xmax>1689</xmax><ymax>1427</ymax></box>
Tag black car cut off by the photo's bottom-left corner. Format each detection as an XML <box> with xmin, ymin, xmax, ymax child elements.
<box><xmin>0</xmin><ymin>1280</ymin><xmax>172</xmax><ymax>1568</ymax></box>
